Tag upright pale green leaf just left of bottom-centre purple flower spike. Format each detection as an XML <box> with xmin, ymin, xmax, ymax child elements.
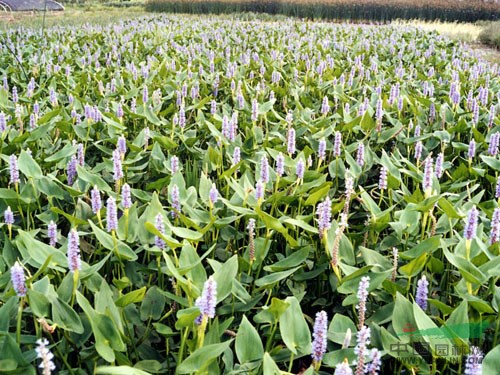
<box><xmin>279</xmin><ymin>297</ymin><xmax>311</xmax><ymax>355</ymax></box>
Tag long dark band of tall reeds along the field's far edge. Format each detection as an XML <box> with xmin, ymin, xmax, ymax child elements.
<box><xmin>146</xmin><ymin>0</ymin><xmax>500</xmax><ymax>22</ymax></box>
